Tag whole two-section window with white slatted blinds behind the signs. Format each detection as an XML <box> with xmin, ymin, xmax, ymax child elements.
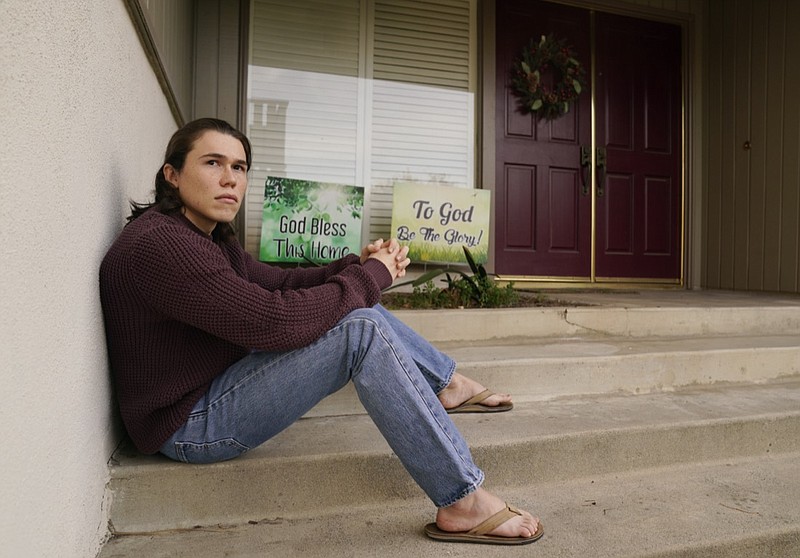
<box><xmin>244</xmin><ymin>0</ymin><xmax>475</xmax><ymax>254</ymax></box>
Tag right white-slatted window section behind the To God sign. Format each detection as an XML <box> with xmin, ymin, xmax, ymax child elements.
<box><xmin>369</xmin><ymin>0</ymin><xmax>475</xmax><ymax>238</ymax></box>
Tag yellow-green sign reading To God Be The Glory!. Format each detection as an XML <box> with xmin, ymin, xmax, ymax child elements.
<box><xmin>392</xmin><ymin>182</ymin><xmax>491</xmax><ymax>263</ymax></box>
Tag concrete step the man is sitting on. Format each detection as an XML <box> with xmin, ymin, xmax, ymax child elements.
<box><xmin>104</xmin><ymin>380</ymin><xmax>800</xmax><ymax>534</ymax></box>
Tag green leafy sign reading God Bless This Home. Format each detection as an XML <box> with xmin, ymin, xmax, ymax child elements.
<box><xmin>259</xmin><ymin>176</ymin><xmax>364</xmax><ymax>264</ymax></box>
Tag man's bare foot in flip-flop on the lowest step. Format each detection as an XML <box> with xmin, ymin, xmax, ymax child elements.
<box><xmin>436</xmin><ymin>488</ymin><xmax>539</xmax><ymax>538</ymax></box>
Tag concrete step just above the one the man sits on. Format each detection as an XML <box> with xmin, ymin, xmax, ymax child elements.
<box><xmin>308</xmin><ymin>334</ymin><xmax>800</xmax><ymax>417</ymax></box>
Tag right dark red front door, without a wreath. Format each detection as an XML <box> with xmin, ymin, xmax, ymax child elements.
<box><xmin>595</xmin><ymin>13</ymin><xmax>682</xmax><ymax>279</ymax></box>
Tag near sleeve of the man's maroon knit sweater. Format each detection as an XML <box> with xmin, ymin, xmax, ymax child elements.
<box><xmin>128</xmin><ymin>227</ymin><xmax>391</xmax><ymax>351</ymax></box>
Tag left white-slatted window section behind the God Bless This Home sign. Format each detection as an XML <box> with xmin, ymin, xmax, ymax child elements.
<box><xmin>244</xmin><ymin>0</ymin><xmax>360</xmax><ymax>255</ymax></box>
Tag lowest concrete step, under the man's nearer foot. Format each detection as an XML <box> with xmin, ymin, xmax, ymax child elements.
<box><xmin>100</xmin><ymin>453</ymin><xmax>800</xmax><ymax>558</ymax></box>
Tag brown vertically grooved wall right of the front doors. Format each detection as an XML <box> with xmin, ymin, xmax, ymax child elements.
<box><xmin>703</xmin><ymin>0</ymin><xmax>800</xmax><ymax>292</ymax></box>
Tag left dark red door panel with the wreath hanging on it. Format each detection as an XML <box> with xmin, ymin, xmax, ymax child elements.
<box><xmin>495</xmin><ymin>0</ymin><xmax>591</xmax><ymax>277</ymax></box>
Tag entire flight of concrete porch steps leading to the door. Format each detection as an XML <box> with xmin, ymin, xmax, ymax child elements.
<box><xmin>101</xmin><ymin>292</ymin><xmax>800</xmax><ymax>558</ymax></box>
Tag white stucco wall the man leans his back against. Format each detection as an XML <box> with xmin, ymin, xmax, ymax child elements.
<box><xmin>0</xmin><ymin>0</ymin><xmax>175</xmax><ymax>558</ymax></box>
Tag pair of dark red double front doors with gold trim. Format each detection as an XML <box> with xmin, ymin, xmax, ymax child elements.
<box><xmin>495</xmin><ymin>0</ymin><xmax>682</xmax><ymax>281</ymax></box>
